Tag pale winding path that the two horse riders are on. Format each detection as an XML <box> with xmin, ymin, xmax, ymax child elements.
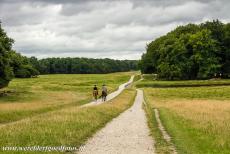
<box><xmin>81</xmin><ymin>75</ymin><xmax>134</xmax><ymax>107</ymax></box>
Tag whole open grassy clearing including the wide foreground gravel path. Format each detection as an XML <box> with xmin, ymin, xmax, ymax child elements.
<box><xmin>0</xmin><ymin>73</ymin><xmax>230</xmax><ymax>154</ymax></box>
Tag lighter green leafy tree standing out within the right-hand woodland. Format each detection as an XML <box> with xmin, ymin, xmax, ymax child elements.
<box><xmin>189</xmin><ymin>29</ymin><xmax>221</xmax><ymax>79</ymax></box>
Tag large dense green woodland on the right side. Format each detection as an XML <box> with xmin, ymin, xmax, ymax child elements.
<box><xmin>140</xmin><ymin>20</ymin><xmax>230</xmax><ymax>80</ymax></box>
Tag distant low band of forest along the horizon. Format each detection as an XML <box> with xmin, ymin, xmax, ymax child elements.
<box><xmin>29</xmin><ymin>57</ymin><xmax>138</xmax><ymax>74</ymax></box>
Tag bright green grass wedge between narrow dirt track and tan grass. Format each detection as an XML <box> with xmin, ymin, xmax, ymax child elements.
<box><xmin>160</xmin><ymin>108</ymin><xmax>230</xmax><ymax>154</ymax></box>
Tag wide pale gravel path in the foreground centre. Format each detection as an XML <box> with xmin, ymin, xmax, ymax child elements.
<box><xmin>79</xmin><ymin>90</ymin><xmax>154</xmax><ymax>154</ymax></box>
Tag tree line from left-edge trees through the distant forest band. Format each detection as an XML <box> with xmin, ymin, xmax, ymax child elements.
<box><xmin>0</xmin><ymin>22</ymin><xmax>138</xmax><ymax>88</ymax></box>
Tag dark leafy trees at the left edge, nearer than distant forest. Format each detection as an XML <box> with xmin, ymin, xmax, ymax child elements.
<box><xmin>0</xmin><ymin>22</ymin><xmax>39</xmax><ymax>88</ymax></box>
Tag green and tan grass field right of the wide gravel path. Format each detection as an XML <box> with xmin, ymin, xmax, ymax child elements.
<box><xmin>143</xmin><ymin>80</ymin><xmax>230</xmax><ymax>154</ymax></box>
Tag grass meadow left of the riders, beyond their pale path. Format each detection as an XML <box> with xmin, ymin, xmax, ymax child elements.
<box><xmin>0</xmin><ymin>72</ymin><xmax>133</xmax><ymax>125</ymax></box>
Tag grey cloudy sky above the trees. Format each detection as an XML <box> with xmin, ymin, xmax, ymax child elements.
<box><xmin>0</xmin><ymin>0</ymin><xmax>230</xmax><ymax>59</ymax></box>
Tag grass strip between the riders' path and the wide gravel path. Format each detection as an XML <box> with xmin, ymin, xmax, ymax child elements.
<box><xmin>0</xmin><ymin>89</ymin><xmax>136</xmax><ymax>153</ymax></box>
